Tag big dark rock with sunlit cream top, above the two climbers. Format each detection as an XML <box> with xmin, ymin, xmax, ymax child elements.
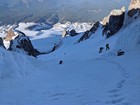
<box><xmin>102</xmin><ymin>7</ymin><xmax>125</xmax><ymax>38</ymax></box>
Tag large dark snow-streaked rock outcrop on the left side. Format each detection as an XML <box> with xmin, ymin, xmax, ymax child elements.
<box><xmin>9</xmin><ymin>31</ymin><xmax>39</xmax><ymax>57</ymax></box>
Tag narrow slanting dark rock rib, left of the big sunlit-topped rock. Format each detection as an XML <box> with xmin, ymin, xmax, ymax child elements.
<box><xmin>78</xmin><ymin>21</ymin><xmax>100</xmax><ymax>43</ymax></box>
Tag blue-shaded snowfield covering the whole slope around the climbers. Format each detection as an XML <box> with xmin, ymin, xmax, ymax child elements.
<box><xmin>0</xmin><ymin>20</ymin><xmax>140</xmax><ymax>105</ymax></box>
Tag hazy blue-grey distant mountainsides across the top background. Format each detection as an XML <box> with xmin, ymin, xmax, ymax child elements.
<box><xmin>0</xmin><ymin>0</ymin><xmax>130</xmax><ymax>24</ymax></box>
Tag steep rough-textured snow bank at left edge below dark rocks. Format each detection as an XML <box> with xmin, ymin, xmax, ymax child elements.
<box><xmin>0</xmin><ymin>47</ymin><xmax>36</xmax><ymax>79</ymax></box>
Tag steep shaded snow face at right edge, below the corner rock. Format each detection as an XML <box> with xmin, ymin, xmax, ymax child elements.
<box><xmin>116</xmin><ymin>18</ymin><xmax>140</xmax><ymax>48</ymax></box>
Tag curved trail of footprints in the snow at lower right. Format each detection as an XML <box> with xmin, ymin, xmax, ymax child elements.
<box><xmin>95</xmin><ymin>58</ymin><xmax>131</xmax><ymax>105</ymax></box>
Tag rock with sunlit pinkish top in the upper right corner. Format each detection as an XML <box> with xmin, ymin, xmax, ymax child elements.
<box><xmin>128</xmin><ymin>0</ymin><xmax>140</xmax><ymax>18</ymax></box>
